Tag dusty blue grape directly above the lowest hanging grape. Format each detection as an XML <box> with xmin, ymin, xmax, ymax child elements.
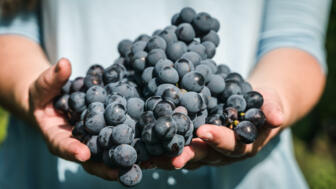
<box><xmin>113</xmin><ymin>144</ymin><xmax>137</xmax><ymax>168</ymax></box>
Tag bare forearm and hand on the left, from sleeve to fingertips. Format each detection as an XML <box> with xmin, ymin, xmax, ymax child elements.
<box><xmin>0</xmin><ymin>35</ymin><xmax>118</xmax><ymax>180</ymax></box>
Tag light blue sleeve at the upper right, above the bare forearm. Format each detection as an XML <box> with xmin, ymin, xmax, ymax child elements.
<box><xmin>257</xmin><ymin>0</ymin><xmax>331</xmax><ymax>73</ymax></box>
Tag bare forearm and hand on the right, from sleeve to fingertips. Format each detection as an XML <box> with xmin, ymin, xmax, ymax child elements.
<box><xmin>152</xmin><ymin>48</ymin><xmax>325</xmax><ymax>169</ymax></box>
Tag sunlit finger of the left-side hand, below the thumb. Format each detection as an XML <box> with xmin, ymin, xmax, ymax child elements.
<box><xmin>42</xmin><ymin>118</ymin><xmax>90</xmax><ymax>162</ymax></box>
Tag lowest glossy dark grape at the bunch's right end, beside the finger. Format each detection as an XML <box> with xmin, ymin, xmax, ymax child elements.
<box><xmin>234</xmin><ymin>121</ymin><xmax>258</xmax><ymax>144</ymax></box>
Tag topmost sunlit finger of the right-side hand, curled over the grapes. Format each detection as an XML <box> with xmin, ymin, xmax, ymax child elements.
<box><xmin>196</xmin><ymin>125</ymin><xmax>249</xmax><ymax>157</ymax></box>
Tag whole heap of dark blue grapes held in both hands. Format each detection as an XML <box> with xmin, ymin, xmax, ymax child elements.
<box><xmin>54</xmin><ymin>7</ymin><xmax>266</xmax><ymax>186</ymax></box>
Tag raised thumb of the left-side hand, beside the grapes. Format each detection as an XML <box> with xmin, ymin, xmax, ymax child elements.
<box><xmin>30</xmin><ymin>58</ymin><xmax>71</xmax><ymax>106</ymax></box>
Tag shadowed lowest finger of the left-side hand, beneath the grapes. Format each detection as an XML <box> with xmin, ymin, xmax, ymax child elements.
<box><xmin>82</xmin><ymin>161</ymin><xmax>118</xmax><ymax>181</ymax></box>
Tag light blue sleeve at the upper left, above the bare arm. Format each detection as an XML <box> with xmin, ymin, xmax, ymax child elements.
<box><xmin>0</xmin><ymin>12</ymin><xmax>42</xmax><ymax>44</ymax></box>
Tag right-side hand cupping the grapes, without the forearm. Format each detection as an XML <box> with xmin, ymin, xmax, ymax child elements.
<box><xmin>155</xmin><ymin>88</ymin><xmax>286</xmax><ymax>169</ymax></box>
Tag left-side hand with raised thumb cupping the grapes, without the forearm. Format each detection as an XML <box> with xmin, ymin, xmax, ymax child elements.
<box><xmin>29</xmin><ymin>58</ymin><xmax>117</xmax><ymax>180</ymax></box>
